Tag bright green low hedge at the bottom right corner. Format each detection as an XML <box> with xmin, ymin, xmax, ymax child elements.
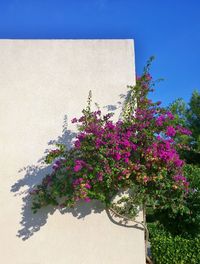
<box><xmin>149</xmin><ymin>227</ymin><xmax>200</xmax><ymax>264</ymax></box>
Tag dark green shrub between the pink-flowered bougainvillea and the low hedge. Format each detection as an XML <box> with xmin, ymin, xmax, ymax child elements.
<box><xmin>152</xmin><ymin>165</ymin><xmax>200</xmax><ymax>238</ymax></box>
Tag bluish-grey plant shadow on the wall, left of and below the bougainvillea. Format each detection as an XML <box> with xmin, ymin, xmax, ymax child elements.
<box><xmin>11</xmin><ymin>116</ymin><xmax>104</xmax><ymax>241</ymax></box>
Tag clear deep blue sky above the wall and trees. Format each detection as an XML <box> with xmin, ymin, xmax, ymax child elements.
<box><xmin>0</xmin><ymin>0</ymin><xmax>200</xmax><ymax>105</ymax></box>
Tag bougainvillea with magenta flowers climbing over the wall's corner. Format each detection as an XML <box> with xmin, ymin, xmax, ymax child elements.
<box><xmin>31</xmin><ymin>58</ymin><xmax>190</xmax><ymax>219</ymax></box>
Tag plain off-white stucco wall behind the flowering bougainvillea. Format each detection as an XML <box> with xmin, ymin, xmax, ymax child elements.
<box><xmin>0</xmin><ymin>40</ymin><xmax>144</xmax><ymax>264</ymax></box>
